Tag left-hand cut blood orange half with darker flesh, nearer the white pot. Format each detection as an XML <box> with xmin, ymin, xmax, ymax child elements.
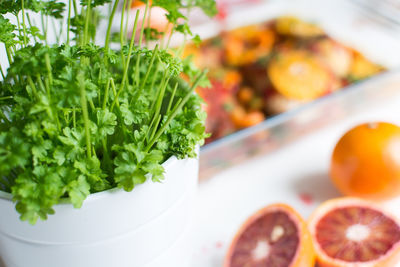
<box><xmin>224</xmin><ymin>204</ymin><xmax>315</xmax><ymax>267</ymax></box>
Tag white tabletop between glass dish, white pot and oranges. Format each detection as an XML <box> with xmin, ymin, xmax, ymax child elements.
<box><xmin>191</xmin><ymin>90</ymin><xmax>400</xmax><ymax>267</ymax></box>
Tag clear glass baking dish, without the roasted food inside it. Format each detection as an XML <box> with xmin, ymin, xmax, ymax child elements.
<box><xmin>194</xmin><ymin>0</ymin><xmax>400</xmax><ymax>179</ymax></box>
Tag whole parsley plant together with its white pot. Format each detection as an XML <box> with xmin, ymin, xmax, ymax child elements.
<box><xmin>0</xmin><ymin>0</ymin><xmax>216</xmax><ymax>267</ymax></box>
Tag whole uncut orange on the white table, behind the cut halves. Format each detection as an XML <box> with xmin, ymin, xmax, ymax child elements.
<box><xmin>330</xmin><ymin>122</ymin><xmax>400</xmax><ymax>200</ymax></box>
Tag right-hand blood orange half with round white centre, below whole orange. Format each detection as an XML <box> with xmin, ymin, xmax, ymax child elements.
<box><xmin>309</xmin><ymin>198</ymin><xmax>400</xmax><ymax>267</ymax></box>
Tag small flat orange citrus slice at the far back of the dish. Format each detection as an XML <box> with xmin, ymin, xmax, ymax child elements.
<box><xmin>275</xmin><ymin>16</ymin><xmax>324</xmax><ymax>38</ymax></box>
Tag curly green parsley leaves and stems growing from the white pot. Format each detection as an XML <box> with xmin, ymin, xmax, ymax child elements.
<box><xmin>0</xmin><ymin>0</ymin><xmax>215</xmax><ymax>224</ymax></box>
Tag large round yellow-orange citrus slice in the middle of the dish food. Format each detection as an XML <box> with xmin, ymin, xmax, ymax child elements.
<box><xmin>268</xmin><ymin>50</ymin><xmax>332</xmax><ymax>100</ymax></box>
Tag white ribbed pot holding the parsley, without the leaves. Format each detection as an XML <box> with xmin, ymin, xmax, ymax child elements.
<box><xmin>0</xmin><ymin>157</ymin><xmax>198</xmax><ymax>267</ymax></box>
